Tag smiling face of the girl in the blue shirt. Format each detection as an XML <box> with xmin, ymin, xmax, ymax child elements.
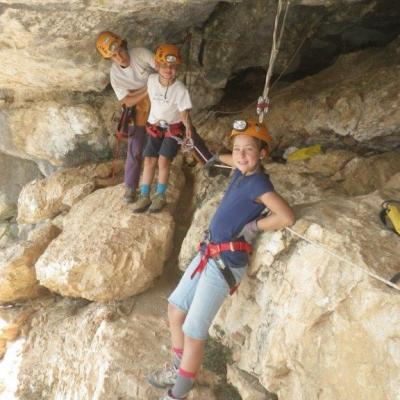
<box><xmin>232</xmin><ymin>135</ymin><xmax>266</xmax><ymax>175</ymax></box>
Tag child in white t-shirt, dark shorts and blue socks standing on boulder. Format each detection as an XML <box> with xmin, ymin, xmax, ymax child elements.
<box><xmin>133</xmin><ymin>44</ymin><xmax>193</xmax><ymax>213</ymax></box>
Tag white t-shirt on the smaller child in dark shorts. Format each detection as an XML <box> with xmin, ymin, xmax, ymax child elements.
<box><xmin>147</xmin><ymin>74</ymin><xmax>192</xmax><ymax>124</ymax></box>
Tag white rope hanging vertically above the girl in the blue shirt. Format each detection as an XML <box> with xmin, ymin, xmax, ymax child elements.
<box><xmin>259</xmin><ymin>0</ymin><xmax>290</xmax><ymax>123</ymax></box>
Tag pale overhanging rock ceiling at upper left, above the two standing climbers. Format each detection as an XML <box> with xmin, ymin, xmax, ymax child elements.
<box><xmin>0</xmin><ymin>0</ymin><xmax>217</xmax><ymax>92</ymax></box>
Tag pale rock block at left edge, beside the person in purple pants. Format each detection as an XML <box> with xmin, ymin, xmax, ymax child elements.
<box><xmin>0</xmin><ymin>101</ymin><xmax>110</xmax><ymax>167</ymax></box>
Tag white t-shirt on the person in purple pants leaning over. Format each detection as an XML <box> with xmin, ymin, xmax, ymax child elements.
<box><xmin>110</xmin><ymin>47</ymin><xmax>155</xmax><ymax>100</ymax></box>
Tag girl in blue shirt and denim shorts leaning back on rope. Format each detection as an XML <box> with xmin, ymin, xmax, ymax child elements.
<box><xmin>148</xmin><ymin>121</ymin><xmax>295</xmax><ymax>400</ymax></box>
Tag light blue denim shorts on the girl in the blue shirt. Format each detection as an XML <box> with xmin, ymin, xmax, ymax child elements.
<box><xmin>168</xmin><ymin>253</ymin><xmax>246</xmax><ymax>340</ymax></box>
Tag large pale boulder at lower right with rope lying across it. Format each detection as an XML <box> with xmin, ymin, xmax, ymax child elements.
<box><xmin>212</xmin><ymin>193</ymin><xmax>400</xmax><ymax>400</ymax></box>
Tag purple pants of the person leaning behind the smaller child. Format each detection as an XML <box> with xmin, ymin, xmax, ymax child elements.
<box><xmin>124</xmin><ymin>126</ymin><xmax>146</xmax><ymax>190</ymax></box>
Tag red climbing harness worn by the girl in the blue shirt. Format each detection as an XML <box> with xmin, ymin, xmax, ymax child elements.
<box><xmin>191</xmin><ymin>231</ymin><xmax>253</xmax><ymax>295</ymax></box>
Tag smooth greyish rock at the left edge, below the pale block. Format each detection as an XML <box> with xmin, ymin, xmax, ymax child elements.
<box><xmin>0</xmin><ymin>153</ymin><xmax>40</xmax><ymax>220</ymax></box>
